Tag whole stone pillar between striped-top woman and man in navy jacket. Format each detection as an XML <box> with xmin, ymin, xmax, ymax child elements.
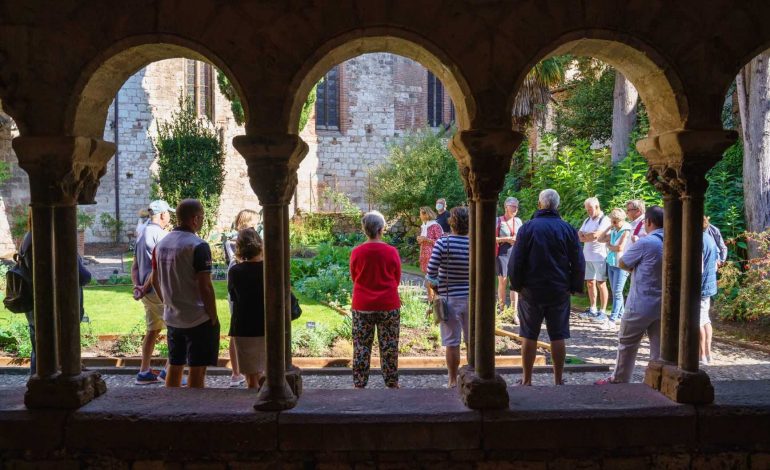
<box><xmin>450</xmin><ymin>129</ymin><xmax>524</xmax><ymax>409</ymax></box>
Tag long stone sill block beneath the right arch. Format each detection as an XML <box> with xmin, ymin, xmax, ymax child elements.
<box><xmin>484</xmin><ymin>384</ymin><xmax>696</xmax><ymax>451</ymax></box>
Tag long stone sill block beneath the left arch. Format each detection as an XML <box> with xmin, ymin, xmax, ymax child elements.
<box><xmin>66</xmin><ymin>387</ymin><xmax>278</xmax><ymax>459</ymax></box>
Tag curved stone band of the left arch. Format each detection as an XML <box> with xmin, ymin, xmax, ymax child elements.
<box><xmin>65</xmin><ymin>35</ymin><xmax>249</xmax><ymax>139</ymax></box>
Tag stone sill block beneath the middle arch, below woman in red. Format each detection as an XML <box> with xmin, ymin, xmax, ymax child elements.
<box><xmin>279</xmin><ymin>389</ymin><xmax>481</xmax><ymax>451</ymax></box>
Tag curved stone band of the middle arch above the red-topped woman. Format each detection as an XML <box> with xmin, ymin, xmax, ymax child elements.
<box><xmin>286</xmin><ymin>28</ymin><xmax>476</xmax><ymax>133</ymax></box>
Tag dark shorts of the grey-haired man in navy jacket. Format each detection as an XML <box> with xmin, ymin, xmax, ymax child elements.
<box><xmin>519</xmin><ymin>296</ymin><xmax>570</xmax><ymax>341</ymax></box>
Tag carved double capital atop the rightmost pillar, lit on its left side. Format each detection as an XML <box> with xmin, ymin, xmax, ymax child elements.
<box><xmin>636</xmin><ymin>130</ymin><xmax>738</xmax><ymax>197</ymax></box>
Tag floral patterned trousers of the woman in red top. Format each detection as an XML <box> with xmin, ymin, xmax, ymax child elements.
<box><xmin>353</xmin><ymin>309</ymin><xmax>401</xmax><ymax>387</ymax></box>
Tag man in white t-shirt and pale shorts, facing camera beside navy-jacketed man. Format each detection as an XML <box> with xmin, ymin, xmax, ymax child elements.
<box><xmin>578</xmin><ymin>197</ymin><xmax>610</xmax><ymax>321</ymax></box>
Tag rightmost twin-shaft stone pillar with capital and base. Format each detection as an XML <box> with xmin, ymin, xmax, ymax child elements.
<box><xmin>638</xmin><ymin>130</ymin><xmax>737</xmax><ymax>404</ymax></box>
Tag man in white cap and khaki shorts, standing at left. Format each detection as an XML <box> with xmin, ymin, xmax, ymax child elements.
<box><xmin>131</xmin><ymin>199</ymin><xmax>174</xmax><ymax>385</ymax></box>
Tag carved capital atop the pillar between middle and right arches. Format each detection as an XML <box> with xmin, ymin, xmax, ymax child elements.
<box><xmin>449</xmin><ymin>129</ymin><xmax>524</xmax><ymax>200</ymax></box>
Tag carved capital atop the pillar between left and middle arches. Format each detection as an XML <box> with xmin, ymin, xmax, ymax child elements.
<box><xmin>233</xmin><ymin>134</ymin><xmax>308</xmax><ymax>206</ymax></box>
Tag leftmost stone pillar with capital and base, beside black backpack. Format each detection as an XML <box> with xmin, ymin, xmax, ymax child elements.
<box><xmin>13</xmin><ymin>136</ymin><xmax>115</xmax><ymax>408</ymax></box>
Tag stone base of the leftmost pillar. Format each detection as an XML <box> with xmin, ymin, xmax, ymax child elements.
<box><xmin>24</xmin><ymin>372</ymin><xmax>107</xmax><ymax>409</ymax></box>
